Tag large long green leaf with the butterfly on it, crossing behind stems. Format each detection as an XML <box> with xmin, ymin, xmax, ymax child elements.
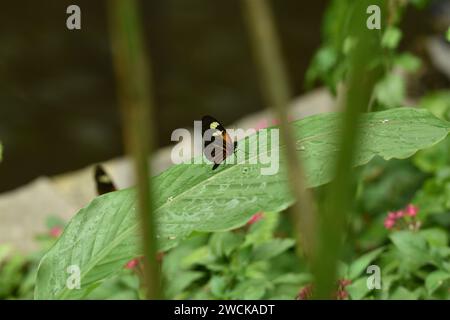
<box><xmin>35</xmin><ymin>108</ymin><xmax>450</xmax><ymax>299</ymax></box>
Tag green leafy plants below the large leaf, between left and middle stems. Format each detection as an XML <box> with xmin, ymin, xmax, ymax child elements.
<box><xmin>163</xmin><ymin>212</ymin><xmax>310</xmax><ymax>299</ymax></box>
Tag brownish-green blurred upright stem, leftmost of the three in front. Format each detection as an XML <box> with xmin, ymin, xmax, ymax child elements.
<box><xmin>108</xmin><ymin>0</ymin><xmax>161</xmax><ymax>299</ymax></box>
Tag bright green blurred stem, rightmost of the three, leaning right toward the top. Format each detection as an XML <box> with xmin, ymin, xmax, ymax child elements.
<box><xmin>313</xmin><ymin>0</ymin><xmax>384</xmax><ymax>299</ymax></box>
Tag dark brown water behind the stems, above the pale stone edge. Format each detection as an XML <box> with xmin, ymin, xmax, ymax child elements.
<box><xmin>0</xmin><ymin>0</ymin><xmax>434</xmax><ymax>191</ymax></box>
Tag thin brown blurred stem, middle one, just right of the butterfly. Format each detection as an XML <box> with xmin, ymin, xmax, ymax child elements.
<box><xmin>242</xmin><ymin>0</ymin><xmax>314</xmax><ymax>255</ymax></box>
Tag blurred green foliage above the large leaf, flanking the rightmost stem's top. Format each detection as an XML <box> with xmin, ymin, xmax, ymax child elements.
<box><xmin>305</xmin><ymin>0</ymin><xmax>428</xmax><ymax>110</ymax></box>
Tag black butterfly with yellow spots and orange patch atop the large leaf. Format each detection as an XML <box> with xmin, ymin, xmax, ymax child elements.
<box><xmin>202</xmin><ymin>116</ymin><xmax>237</xmax><ymax>170</ymax></box>
